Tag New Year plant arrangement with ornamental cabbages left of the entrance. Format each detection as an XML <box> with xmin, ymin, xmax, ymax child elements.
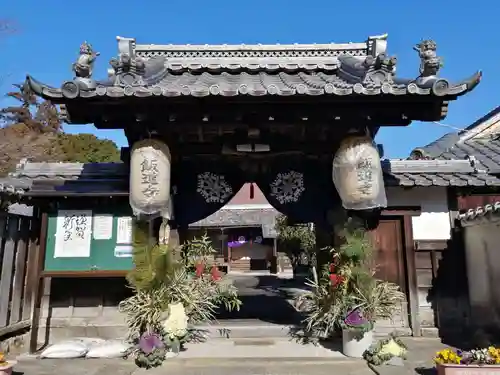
<box><xmin>119</xmin><ymin>222</ymin><xmax>241</xmax><ymax>368</ymax></box>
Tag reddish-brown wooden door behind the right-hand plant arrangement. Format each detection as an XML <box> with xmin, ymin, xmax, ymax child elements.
<box><xmin>372</xmin><ymin>218</ymin><xmax>406</xmax><ymax>291</ymax></box>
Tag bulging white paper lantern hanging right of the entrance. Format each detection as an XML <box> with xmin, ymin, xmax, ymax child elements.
<box><xmin>332</xmin><ymin>136</ymin><xmax>387</xmax><ymax>210</ymax></box>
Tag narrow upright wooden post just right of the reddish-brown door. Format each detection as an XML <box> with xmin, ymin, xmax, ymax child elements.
<box><xmin>403</xmin><ymin>215</ymin><xmax>422</xmax><ymax>336</ymax></box>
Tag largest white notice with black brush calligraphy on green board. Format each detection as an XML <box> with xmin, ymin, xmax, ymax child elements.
<box><xmin>54</xmin><ymin>210</ymin><xmax>92</xmax><ymax>258</ymax></box>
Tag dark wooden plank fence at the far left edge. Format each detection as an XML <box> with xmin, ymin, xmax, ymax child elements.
<box><xmin>0</xmin><ymin>213</ymin><xmax>39</xmax><ymax>338</ymax></box>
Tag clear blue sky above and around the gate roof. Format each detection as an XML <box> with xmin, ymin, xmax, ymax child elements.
<box><xmin>0</xmin><ymin>0</ymin><xmax>500</xmax><ymax>157</ymax></box>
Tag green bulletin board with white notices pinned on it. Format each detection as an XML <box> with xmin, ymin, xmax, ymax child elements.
<box><xmin>44</xmin><ymin>205</ymin><xmax>133</xmax><ymax>273</ymax></box>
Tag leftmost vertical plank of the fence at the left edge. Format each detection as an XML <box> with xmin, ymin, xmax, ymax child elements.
<box><xmin>0</xmin><ymin>215</ymin><xmax>19</xmax><ymax>327</ymax></box>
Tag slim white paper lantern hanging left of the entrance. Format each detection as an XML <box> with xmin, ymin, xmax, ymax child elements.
<box><xmin>130</xmin><ymin>139</ymin><xmax>172</xmax><ymax>219</ymax></box>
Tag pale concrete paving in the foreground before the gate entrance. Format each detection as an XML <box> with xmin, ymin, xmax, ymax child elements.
<box><xmin>10</xmin><ymin>338</ymin><xmax>446</xmax><ymax>375</ymax></box>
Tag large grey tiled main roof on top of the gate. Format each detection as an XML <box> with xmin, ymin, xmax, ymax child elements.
<box><xmin>25</xmin><ymin>35</ymin><xmax>481</xmax><ymax>102</ymax></box>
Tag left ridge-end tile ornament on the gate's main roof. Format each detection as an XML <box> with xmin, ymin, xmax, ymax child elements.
<box><xmin>108</xmin><ymin>37</ymin><xmax>146</xmax><ymax>86</ymax></box>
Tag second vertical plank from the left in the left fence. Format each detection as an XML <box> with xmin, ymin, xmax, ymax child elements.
<box><xmin>9</xmin><ymin>216</ymin><xmax>31</xmax><ymax>324</ymax></box>
